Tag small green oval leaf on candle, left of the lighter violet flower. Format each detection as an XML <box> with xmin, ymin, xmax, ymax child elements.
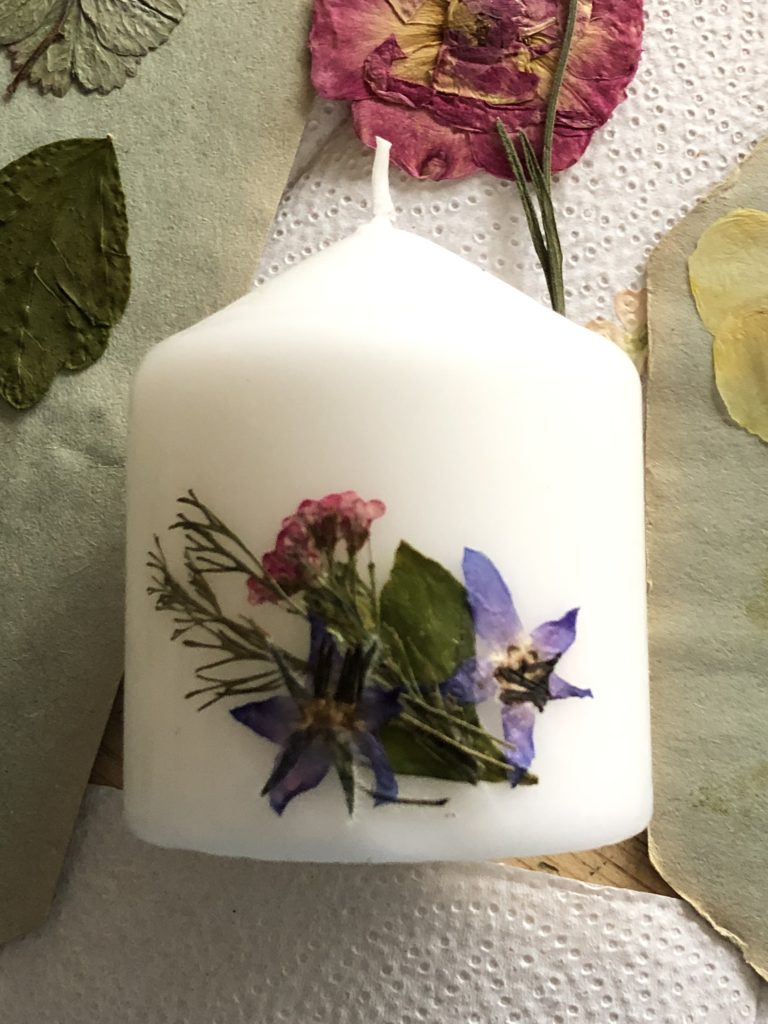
<box><xmin>381</xmin><ymin>541</ymin><xmax>474</xmax><ymax>684</ymax></box>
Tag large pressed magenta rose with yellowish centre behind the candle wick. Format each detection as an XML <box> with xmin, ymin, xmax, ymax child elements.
<box><xmin>310</xmin><ymin>0</ymin><xmax>643</xmax><ymax>180</ymax></box>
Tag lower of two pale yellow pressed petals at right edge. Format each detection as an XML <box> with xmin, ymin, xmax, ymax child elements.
<box><xmin>715</xmin><ymin>309</ymin><xmax>768</xmax><ymax>441</ymax></box>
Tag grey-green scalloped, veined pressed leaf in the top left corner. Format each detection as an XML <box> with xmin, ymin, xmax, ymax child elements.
<box><xmin>0</xmin><ymin>0</ymin><xmax>187</xmax><ymax>96</ymax></box>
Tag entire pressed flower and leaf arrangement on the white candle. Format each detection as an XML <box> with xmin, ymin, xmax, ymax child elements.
<box><xmin>148</xmin><ymin>492</ymin><xmax>591</xmax><ymax>814</ymax></box>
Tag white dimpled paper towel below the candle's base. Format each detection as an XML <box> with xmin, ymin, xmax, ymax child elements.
<box><xmin>0</xmin><ymin>786</ymin><xmax>768</xmax><ymax>1024</ymax></box>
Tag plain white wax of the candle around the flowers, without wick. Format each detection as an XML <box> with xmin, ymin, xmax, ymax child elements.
<box><xmin>125</xmin><ymin>218</ymin><xmax>651</xmax><ymax>861</ymax></box>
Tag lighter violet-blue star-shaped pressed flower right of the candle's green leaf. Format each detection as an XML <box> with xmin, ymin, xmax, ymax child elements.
<box><xmin>443</xmin><ymin>548</ymin><xmax>592</xmax><ymax>785</ymax></box>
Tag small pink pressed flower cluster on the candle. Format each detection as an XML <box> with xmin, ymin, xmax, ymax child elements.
<box><xmin>248</xmin><ymin>490</ymin><xmax>386</xmax><ymax>604</ymax></box>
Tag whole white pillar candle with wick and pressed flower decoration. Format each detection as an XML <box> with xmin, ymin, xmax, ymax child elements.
<box><xmin>125</xmin><ymin>140</ymin><xmax>651</xmax><ymax>861</ymax></box>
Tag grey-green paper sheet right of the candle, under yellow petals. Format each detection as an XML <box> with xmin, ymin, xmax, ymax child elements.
<box><xmin>648</xmin><ymin>140</ymin><xmax>768</xmax><ymax>978</ymax></box>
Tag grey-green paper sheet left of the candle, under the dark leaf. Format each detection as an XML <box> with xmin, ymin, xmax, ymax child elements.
<box><xmin>0</xmin><ymin>0</ymin><xmax>309</xmax><ymax>940</ymax></box>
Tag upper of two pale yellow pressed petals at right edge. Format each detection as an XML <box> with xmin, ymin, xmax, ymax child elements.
<box><xmin>688</xmin><ymin>209</ymin><xmax>768</xmax><ymax>334</ymax></box>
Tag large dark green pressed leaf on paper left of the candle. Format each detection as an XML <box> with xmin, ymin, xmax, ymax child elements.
<box><xmin>0</xmin><ymin>138</ymin><xmax>130</xmax><ymax>409</ymax></box>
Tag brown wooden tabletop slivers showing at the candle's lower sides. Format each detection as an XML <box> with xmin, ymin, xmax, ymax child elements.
<box><xmin>91</xmin><ymin>693</ymin><xmax>675</xmax><ymax>896</ymax></box>
